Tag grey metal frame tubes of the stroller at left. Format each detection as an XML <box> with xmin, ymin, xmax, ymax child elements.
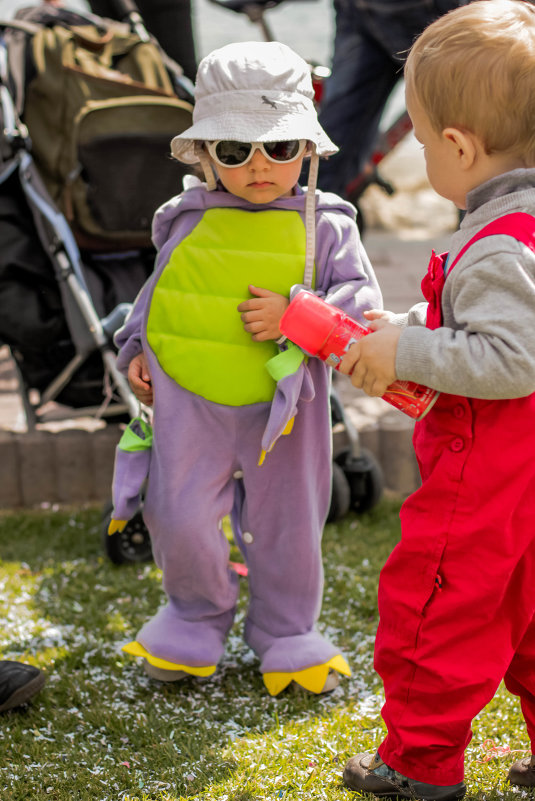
<box><xmin>0</xmin><ymin>10</ymin><xmax>183</xmax><ymax>430</ymax></box>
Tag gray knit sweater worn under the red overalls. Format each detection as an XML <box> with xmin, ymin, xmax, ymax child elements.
<box><xmin>392</xmin><ymin>169</ymin><xmax>535</xmax><ymax>399</ymax></box>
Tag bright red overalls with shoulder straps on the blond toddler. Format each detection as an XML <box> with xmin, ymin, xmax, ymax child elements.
<box><xmin>375</xmin><ymin>214</ymin><xmax>535</xmax><ymax>785</ymax></box>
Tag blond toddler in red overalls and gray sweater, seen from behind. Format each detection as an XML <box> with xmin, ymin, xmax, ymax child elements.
<box><xmin>341</xmin><ymin>0</ymin><xmax>535</xmax><ymax>799</ymax></box>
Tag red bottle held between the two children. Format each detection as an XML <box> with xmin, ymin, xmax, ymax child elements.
<box><xmin>280</xmin><ymin>292</ymin><xmax>440</xmax><ymax>420</ymax></box>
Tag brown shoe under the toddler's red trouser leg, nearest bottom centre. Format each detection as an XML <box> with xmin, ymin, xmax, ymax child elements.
<box><xmin>344</xmin><ymin>754</ymin><xmax>466</xmax><ymax>801</ymax></box>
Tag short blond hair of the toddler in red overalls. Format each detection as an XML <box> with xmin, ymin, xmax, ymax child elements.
<box><xmin>405</xmin><ymin>0</ymin><xmax>535</xmax><ymax>166</ymax></box>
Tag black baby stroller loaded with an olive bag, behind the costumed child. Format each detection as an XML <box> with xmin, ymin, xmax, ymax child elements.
<box><xmin>0</xmin><ymin>0</ymin><xmax>382</xmax><ymax>563</ymax></box>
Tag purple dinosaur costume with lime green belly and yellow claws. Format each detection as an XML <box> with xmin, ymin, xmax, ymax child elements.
<box><xmin>111</xmin><ymin>42</ymin><xmax>382</xmax><ymax>694</ymax></box>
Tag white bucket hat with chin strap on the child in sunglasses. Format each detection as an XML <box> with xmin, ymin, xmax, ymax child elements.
<box><xmin>171</xmin><ymin>42</ymin><xmax>338</xmax><ymax>290</ymax></box>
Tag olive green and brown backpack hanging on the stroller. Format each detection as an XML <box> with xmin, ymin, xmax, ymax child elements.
<box><xmin>13</xmin><ymin>20</ymin><xmax>192</xmax><ymax>249</ymax></box>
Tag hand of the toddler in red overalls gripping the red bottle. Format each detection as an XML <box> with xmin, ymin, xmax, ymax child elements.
<box><xmin>340</xmin><ymin>313</ymin><xmax>401</xmax><ymax>397</ymax></box>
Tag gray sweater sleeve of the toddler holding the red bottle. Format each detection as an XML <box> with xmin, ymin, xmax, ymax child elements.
<box><xmin>396</xmin><ymin>236</ymin><xmax>535</xmax><ymax>400</ymax></box>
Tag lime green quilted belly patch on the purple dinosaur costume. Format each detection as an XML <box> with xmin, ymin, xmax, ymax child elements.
<box><xmin>147</xmin><ymin>209</ymin><xmax>305</xmax><ymax>406</ymax></box>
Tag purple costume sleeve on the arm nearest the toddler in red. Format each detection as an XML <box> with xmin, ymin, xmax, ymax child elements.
<box><xmin>291</xmin><ymin>211</ymin><xmax>383</xmax><ymax>324</ymax></box>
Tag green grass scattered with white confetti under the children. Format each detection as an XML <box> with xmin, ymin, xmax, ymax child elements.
<box><xmin>0</xmin><ymin>501</ymin><xmax>529</xmax><ymax>801</ymax></box>
